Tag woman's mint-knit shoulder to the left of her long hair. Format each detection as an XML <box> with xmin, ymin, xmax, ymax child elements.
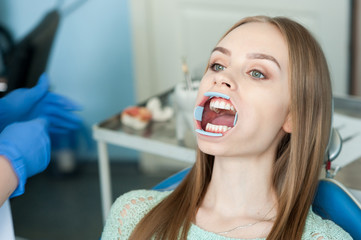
<box><xmin>102</xmin><ymin>190</ymin><xmax>170</xmax><ymax>240</ymax></box>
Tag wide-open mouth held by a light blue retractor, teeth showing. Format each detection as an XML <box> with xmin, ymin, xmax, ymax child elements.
<box><xmin>194</xmin><ymin>92</ymin><xmax>237</xmax><ymax>137</ymax></box>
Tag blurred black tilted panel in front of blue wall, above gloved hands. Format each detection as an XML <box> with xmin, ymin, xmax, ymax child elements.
<box><xmin>6</xmin><ymin>10</ymin><xmax>60</xmax><ymax>92</ymax></box>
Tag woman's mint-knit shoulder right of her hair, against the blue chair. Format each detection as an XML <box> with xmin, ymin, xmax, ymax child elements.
<box><xmin>302</xmin><ymin>209</ymin><xmax>352</xmax><ymax>240</ymax></box>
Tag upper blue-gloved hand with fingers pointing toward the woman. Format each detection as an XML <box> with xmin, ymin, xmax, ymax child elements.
<box><xmin>0</xmin><ymin>73</ymin><xmax>82</xmax><ymax>133</ymax></box>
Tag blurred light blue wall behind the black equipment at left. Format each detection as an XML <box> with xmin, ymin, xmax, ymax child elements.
<box><xmin>0</xmin><ymin>0</ymin><xmax>136</xmax><ymax>158</ymax></box>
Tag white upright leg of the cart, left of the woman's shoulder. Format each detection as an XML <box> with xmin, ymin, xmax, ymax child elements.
<box><xmin>98</xmin><ymin>141</ymin><xmax>112</xmax><ymax>223</ymax></box>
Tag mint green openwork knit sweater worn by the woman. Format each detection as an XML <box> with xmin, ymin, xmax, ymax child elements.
<box><xmin>101</xmin><ymin>190</ymin><xmax>352</xmax><ymax>240</ymax></box>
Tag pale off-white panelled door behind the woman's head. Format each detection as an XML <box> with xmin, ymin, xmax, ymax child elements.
<box><xmin>130</xmin><ymin>0</ymin><xmax>350</xmax><ymax>100</ymax></box>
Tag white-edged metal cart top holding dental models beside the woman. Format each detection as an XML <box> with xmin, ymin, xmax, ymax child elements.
<box><xmin>93</xmin><ymin>88</ymin><xmax>196</xmax><ymax>162</ymax></box>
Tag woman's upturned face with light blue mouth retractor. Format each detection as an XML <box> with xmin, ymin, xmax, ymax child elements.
<box><xmin>195</xmin><ymin>22</ymin><xmax>291</xmax><ymax>157</ymax></box>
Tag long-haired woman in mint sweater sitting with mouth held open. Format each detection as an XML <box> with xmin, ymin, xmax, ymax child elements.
<box><xmin>103</xmin><ymin>16</ymin><xmax>351</xmax><ymax>240</ymax></box>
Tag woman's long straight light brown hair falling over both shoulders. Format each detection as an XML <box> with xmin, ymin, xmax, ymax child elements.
<box><xmin>130</xmin><ymin>16</ymin><xmax>332</xmax><ymax>240</ymax></box>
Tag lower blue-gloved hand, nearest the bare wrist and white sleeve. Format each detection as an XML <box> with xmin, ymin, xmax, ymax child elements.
<box><xmin>0</xmin><ymin>118</ymin><xmax>50</xmax><ymax>197</ymax></box>
